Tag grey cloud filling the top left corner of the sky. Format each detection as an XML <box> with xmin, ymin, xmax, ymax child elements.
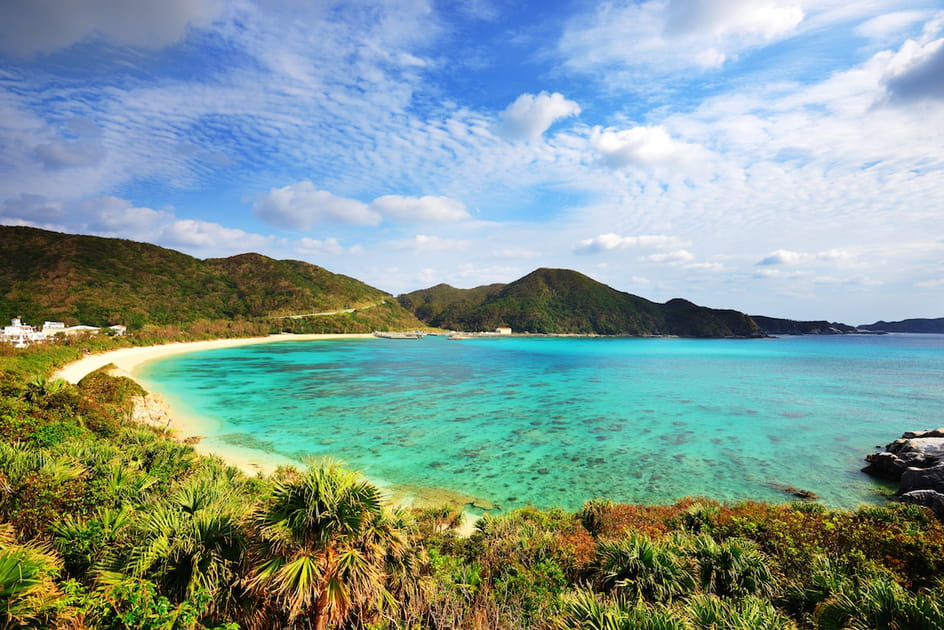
<box><xmin>0</xmin><ymin>0</ymin><xmax>225</xmax><ymax>55</ymax></box>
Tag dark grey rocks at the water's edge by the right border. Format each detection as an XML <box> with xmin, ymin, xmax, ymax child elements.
<box><xmin>862</xmin><ymin>429</ymin><xmax>944</xmax><ymax>520</ymax></box>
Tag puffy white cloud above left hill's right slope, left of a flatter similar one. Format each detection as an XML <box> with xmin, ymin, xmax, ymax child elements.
<box><xmin>252</xmin><ymin>181</ymin><xmax>381</xmax><ymax>230</ymax></box>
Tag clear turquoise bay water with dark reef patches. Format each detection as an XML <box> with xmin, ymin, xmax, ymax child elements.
<box><xmin>139</xmin><ymin>335</ymin><xmax>944</xmax><ymax>509</ymax></box>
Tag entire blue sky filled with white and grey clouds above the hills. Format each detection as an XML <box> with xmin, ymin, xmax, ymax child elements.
<box><xmin>0</xmin><ymin>0</ymin><xmax>944</xmax><ymax>324</ymax></box>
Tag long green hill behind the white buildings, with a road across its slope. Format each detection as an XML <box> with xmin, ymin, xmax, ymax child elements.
<box><xmin>0</xmin><ymin>226</ymin><xmax>420</xmax><ymax>332</ymax></box>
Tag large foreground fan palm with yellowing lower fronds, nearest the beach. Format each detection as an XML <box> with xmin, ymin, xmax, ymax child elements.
<box><xmin>248</xmin><ymin>461</ymin><xmax>399</xmax><ymax>630</ymax></box>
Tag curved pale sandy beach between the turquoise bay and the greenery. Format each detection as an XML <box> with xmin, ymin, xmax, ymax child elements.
<box><xmin>52</xmin><ymin>333</ymin><xmax>487</xmax><ymax>536</ymax></box>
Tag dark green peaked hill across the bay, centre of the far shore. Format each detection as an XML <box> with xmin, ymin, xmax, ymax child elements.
<box><xmin>398</xmin><ymin>269</ymin><xmax>762</xmax><ymax>337</ymax></box>
